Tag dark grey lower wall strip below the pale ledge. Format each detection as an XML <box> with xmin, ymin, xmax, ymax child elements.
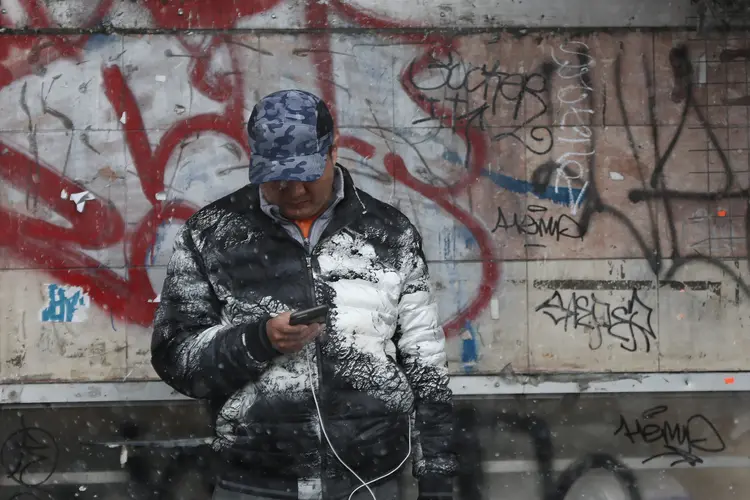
<box><xmin>0</xmin><ymin>393</ymin><xmax>750</xmax><ymax>500</ymax></box>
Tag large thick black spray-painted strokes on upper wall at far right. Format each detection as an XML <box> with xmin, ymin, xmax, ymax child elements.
<box><xmin>531</xmin><ymin>42</ymin><xmax>750</xmax><ymax>295</ymax></box>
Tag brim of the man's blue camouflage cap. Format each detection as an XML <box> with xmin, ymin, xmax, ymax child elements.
<box><xmin>250</xmin><ymin>153</ymin><xmax>326</xmax><ymax>184</ymax></box>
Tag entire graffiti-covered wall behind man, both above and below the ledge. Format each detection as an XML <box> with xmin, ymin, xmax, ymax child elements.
<box><xmin>7</xmin><ymin>0</ymin><xmax>750</xmax><ymax>500</ymax></box>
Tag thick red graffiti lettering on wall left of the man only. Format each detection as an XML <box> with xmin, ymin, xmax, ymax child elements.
<box><xmin>0</xmin><ymin>7</ymin><xmax>247</xmax><ymax>326</ymax></box>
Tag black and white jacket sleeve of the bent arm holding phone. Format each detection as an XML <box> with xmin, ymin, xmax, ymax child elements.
<box><xmin>151</xmin><ymin>224</ymin><xmax>277</xmax><ymax>399</ymax></box>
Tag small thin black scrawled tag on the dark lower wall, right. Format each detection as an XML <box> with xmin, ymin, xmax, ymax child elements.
<box><xmin>614</xmin><ymin>405</ymin><xmax>726</xmax><ymax>467</ymax></box>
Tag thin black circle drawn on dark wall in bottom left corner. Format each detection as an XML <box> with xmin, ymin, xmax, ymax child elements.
<box><xmin>0</xmin><ymin>426</ymin><xmax>60</xmax><ymax>486</ymax></box>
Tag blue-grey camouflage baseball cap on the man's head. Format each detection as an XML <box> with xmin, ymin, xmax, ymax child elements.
<box><xmin>247</xmin><ymin>90</ymin><xmax>333</xmax><ymax>184</ymax></box>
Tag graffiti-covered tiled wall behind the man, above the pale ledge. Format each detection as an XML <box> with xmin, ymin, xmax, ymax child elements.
<box><xmin>0</xmin><ymin>0</ymin><xmax>750</xmax><ymax>381</ymax></box>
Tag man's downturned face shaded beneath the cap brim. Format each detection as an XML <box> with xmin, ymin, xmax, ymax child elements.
<box><xmin>261</xmin><ymin>146</ymin><xmax>336</xmax><ymax>220</ymax></box>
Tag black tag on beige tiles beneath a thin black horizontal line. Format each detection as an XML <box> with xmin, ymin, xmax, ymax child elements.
<box><xmin>534</xmin><ymin>289</ymin><xmax>656</xmax><ymax>352</ymax></box>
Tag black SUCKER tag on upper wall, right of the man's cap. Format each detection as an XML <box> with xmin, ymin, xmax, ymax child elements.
<box><xmin>408</xmin><ymin>52</ymin><xmax>553</xmax><ymax>158</ymax></box>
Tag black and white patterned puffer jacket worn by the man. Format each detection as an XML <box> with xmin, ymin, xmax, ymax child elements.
<box><xmin>152</xmin><ymin>167</ymin><xmax>457</xmax><ymax>498</ymax></box>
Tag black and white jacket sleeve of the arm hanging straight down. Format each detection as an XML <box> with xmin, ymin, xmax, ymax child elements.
<box><xmin>397</xmin><ymin>224</ymin><xmax>458</xmax><ymax>498</ymax></box>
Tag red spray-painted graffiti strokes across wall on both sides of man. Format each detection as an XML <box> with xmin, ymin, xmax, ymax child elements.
<box><xmin>0</xmin><ymin>0</ymin><xmax>500</xmax><ymax>335</ymax></box>
